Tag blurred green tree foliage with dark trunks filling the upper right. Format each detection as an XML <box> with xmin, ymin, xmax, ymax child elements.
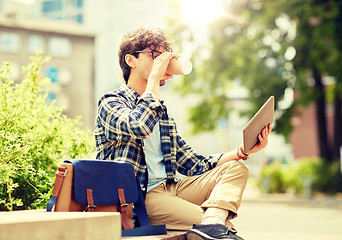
<box><xmin>168</xmin><ymin>0</ymin><xmax>342</xmax><ymax>163</ymax></box>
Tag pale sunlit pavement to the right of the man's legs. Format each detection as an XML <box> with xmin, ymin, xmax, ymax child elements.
<box><xmin>232</xmin><ymin>182</ymin><xmax>342</xmax><ymax>240</ymax></box>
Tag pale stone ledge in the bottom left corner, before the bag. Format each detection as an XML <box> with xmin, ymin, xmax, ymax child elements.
<box><xmin>0</xmin><ymin>211</ymin><xmax>121</xmax><ymax>240</ymax></box>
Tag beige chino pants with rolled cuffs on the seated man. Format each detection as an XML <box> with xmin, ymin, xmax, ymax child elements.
<box><xmin>145</xmin><ymin>160</ymin><xmax>248</xmax><ymax>230</ymax></box>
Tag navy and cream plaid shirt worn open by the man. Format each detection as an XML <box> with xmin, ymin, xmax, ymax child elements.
<box><xmin>95</xmin><ymin>84</ymin><xmax>221</xmax><ymax>190</ymax></box>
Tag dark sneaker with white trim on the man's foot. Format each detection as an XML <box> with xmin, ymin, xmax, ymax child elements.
<box><xmin>186</xmin><ymin>224</ymin><xmax>243</xmax><ymax>240</ymax></box>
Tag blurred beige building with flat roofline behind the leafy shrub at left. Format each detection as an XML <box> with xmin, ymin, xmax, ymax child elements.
<box><xmin>0</xmin><ymin>14</ymin><xmax>95</xmax><ymax>128</ymax></box>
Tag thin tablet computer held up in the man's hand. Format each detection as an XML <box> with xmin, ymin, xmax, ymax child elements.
<box><xmin>243</xmin><ymin>96</ymin><xmax>274</xmax><ymax>153</ymax></box>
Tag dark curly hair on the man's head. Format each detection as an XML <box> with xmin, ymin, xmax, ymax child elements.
<box><xmin>119</xmin><ymin>28</ymin><xmax>172</xmax><ymax>83</ymax></box>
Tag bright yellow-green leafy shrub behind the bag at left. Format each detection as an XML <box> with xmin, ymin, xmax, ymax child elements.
<box><xmin>0</xmin><ymin>54</ymin><xmax>94</xmax><ymax>210</ymax></box>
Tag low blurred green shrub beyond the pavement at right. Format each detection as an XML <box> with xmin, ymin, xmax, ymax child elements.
<box><xmin>257</xmin><ymin>157</ymin><xmax>341</xmax><ymax>196</ymax></box>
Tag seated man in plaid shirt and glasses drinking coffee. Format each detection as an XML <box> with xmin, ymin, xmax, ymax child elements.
<box><xmin>95</xmin><ymin>29</ymin><xmax>271</xmax><ymax>240</ymax></box>
